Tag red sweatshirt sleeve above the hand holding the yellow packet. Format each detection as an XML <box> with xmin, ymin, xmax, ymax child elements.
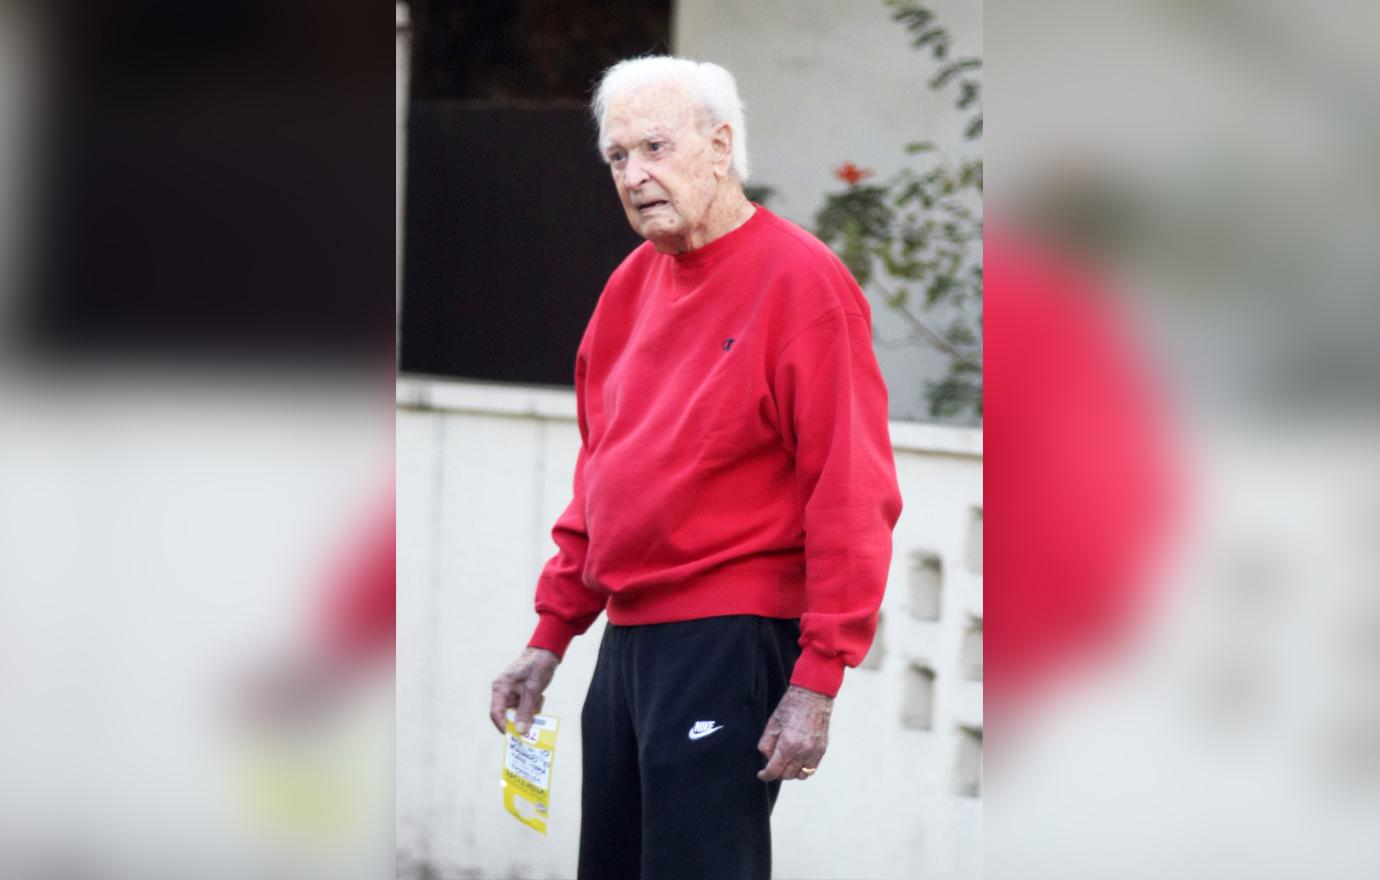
<box><xmin>527</xmin><ymin>353</ymin><xmax>609</xmax><ymax>657</ymax></box>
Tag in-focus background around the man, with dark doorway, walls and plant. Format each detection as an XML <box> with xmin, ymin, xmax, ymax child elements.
<box><xmin>396</xmin><ymin>0</ymin><xmax>983</xmax><ymax>880</ymax></box>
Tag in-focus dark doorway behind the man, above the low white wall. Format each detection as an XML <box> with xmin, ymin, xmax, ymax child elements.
<box><xmin>399</xmin><ymin>0</ymin><xmax>671</xmax><ymax>385</ymax></box>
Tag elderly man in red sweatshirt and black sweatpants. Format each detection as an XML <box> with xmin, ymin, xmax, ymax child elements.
<box><xmin>490</xmin><ymin>58</ymin><xmax>901</xmax><ymax>880</ymax></box>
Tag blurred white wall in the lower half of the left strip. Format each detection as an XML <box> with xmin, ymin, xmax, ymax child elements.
<box><xmin>0</xmin><ymin>383</ymin><xmax>393</xmax><ymax>880</ymax></box>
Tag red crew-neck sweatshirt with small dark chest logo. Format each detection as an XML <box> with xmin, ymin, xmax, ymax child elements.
<box><xmin>529</xmin><ymin>206</ymin><xmax>901</xmax><ymax>695</ymax></box>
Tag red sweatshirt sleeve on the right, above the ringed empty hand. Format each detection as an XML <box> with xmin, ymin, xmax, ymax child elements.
<box><xmin>774</xmin><ymin>306</ymin><xmax>901</xmax><ymax>697</ymax></box>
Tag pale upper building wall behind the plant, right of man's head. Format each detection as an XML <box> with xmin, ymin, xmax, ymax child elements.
<box><xmin>671</xmin><ymin>0</ymin><xmax>983</xmax><ymax>418</ymax></box>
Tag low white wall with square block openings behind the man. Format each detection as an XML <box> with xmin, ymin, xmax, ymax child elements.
<box><xmin>397</xmin><ymin>379</ymin><xmax>983</xmax><ymax>880</ymax></box>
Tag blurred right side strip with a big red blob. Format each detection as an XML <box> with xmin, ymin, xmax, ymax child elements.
<box><xmin>984</xmin><ymin>0</ymin><xmax>1380</xmax><ymax>880</ymax></box>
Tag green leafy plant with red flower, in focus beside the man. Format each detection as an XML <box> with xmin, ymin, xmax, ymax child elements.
<box><xmin>814</xmin><ymin>0</ymin><xmax>983</xmax><ymax>419</ymax></box>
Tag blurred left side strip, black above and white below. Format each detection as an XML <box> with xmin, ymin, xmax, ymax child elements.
<box><xmin>0</xmin><ymin>0</ymin><xmax>395</xmax><ymax>880</ymax></box>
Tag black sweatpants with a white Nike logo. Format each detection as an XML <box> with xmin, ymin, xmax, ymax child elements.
<box><xmin>580</xmin><ymin>615</ymin><xmax>800</xmax><ymax>880</ymax></box>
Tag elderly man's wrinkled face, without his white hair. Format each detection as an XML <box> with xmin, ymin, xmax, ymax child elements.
<box><xmin>604</xmin><ymin>84</ymin><xmax>729</xmax><ymax>252</ymax></box>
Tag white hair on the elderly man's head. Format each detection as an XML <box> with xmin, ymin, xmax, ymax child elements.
<box><xmin>591</xmin><ymin>55</ymin><xmax>748</xmax><ymax>182</ymax></box>
